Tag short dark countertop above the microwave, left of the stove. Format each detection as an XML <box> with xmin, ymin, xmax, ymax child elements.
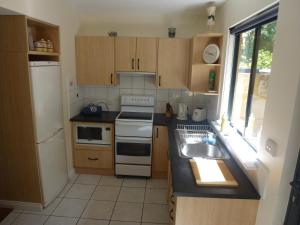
<box><xmin>70</xmin><ymin>111</ymin><xmax>119</xmax><ymax>123</ymax></box>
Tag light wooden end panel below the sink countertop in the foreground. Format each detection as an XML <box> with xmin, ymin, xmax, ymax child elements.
<box><xmin>175</xmin><ymin>197</ymin><xmax>258</xmax><ymax>225</ymax></box>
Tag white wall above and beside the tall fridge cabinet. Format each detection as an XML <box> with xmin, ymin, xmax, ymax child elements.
<box><xmin>0</xmin><ymin>0</ymin><xmax>79</xmax><ymax>179</ymax></box>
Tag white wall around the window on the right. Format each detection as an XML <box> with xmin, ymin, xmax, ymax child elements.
<box><xmin>219</xmin><ymin>0</ymin><xmax>300</xmax><ymax>225</ymax></box>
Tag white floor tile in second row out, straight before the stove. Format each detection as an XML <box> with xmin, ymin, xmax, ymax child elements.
<box><xmin>118</xmin><ymin>187</ymin><xmax>145</xmax><ymax>203</ymax></box>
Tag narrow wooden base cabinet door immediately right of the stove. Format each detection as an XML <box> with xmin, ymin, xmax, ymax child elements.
<box><xmin>152</xmin><ymin>126</ymin><xmax>169</xmax><ymax>178</ymax></box>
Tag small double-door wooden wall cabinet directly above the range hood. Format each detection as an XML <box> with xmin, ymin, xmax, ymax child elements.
<box><xmin>116</xmin><ymin>37</ymin><xmax>157</xmax><ymax>73</ymax></box>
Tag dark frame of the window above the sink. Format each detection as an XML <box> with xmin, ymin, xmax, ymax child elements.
<box><xmin>227</xmin><ymin>3</ymin><xmax>279</xmax><ymax>148</ymax></box>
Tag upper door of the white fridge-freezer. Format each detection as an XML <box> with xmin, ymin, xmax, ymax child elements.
<box><xmin>30</xmin><ymin>65</ymin><xmax>63</xmax><ymax>143</ymax></box>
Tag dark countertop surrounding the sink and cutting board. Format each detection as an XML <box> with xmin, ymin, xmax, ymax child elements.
<box><xmin>168</xmin><ymin>117</ymin><xmax>260</xmax><ymax>199</ymax></box>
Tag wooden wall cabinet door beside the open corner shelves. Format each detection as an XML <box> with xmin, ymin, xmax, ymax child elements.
<box><xmin>157</xmin><ymin>38</ymin><xmax>190</xmax><ymax>88</ymax></box>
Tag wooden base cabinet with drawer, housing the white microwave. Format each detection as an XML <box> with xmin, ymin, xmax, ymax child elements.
<box><xmin>72</xmin><ymin>122</ymin><xmax>114</xmax><ymax>175</ymax></box>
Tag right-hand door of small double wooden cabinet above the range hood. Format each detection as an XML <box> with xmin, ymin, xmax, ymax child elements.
<box><xmin>136</xmin><ymin>38</ymin><xmax>157</xmax><ymax>73</ymax></box>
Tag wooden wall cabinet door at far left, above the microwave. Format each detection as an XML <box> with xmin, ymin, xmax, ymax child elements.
<box><xmin>76</xmin><ymin>37</ymin><xmax>115</xmax><ymax>85</ymax></box>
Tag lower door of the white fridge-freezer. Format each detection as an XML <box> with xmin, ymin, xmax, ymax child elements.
<box><xmin>38</xmin><ymin>129</ymin><xmax>68</xmax><ymax>206</ymax></box>
